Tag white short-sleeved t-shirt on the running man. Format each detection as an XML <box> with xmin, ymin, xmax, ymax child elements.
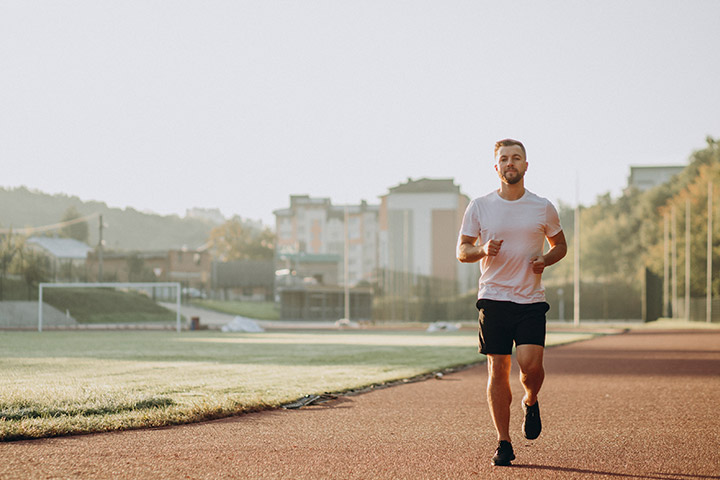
<box><xmin>460</xmin><ymin>189</ymin><xmax>562</xmax><ymax>303</ymax></box>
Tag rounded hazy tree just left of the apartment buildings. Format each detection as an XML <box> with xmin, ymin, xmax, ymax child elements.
<box><xmin>209</xmin><ymin>216</ymin><xmax>275</xmax><ymax>261</ymax></box>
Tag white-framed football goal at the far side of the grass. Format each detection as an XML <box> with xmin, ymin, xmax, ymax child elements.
<box><xmin>38</xmin><ymin>282</ymin><xmax>182</xmax><ymax>332</ymax></box>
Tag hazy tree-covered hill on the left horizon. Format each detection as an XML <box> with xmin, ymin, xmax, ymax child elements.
<box><xmin>0</xmin><ymin>187</ymin><xmax>214</xmax><ymax>250</ymax></box>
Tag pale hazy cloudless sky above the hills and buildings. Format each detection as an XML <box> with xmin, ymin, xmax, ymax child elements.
<box><xmin>0</xmin><ymin>0</ymin><xmax>720</xmax><ymax>224</ymax></box>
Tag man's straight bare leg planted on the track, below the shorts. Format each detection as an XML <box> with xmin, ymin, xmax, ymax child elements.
<box><xmin>487</xmin><ymin>355</ymin><xmax>512</xmax><ymax>442</ymax></box>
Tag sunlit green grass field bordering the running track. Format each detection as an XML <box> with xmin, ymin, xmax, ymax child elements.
<box><xmin>0</xmin><ymin>329</ymin><xmax>590</xmax><ymax>441</ymax></box>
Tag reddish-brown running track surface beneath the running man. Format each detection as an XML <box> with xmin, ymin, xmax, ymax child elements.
<box><xmin>0</xmin><ymin>330</ymin><xmax>720</xmax><ymax>480</ymax></box>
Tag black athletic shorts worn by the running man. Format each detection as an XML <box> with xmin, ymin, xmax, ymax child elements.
<box><xmin>476</xmin><ymin>298</ymin><xmax>550</xmax><ymax>355</ymax></box>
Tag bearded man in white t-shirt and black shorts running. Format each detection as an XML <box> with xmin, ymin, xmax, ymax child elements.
<box><xmin>457</xmin><ymin>139</ymin><xmax>567</xmax><ymax>465</ymax></box>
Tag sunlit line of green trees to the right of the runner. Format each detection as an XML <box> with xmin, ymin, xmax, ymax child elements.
<box><xmin>544</xmin><ymin>137</ymin><xmax>720</xmax><ymax>314</ymax></box>
